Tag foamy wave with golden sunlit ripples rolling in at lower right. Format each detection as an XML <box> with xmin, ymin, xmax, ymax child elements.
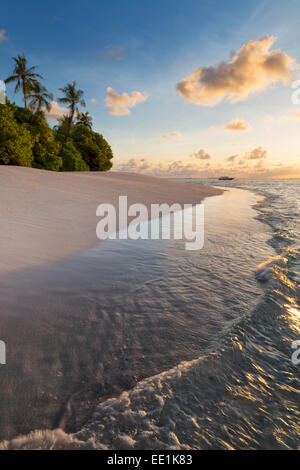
<box><xmin>0</xmin><ymin>182</ymin><xmax>300</xmax><ymax>450</ymax></box>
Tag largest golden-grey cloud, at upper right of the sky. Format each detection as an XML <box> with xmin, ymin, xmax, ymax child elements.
<box><xmin>177</xmin><ymin>36</ymin><xmax>296</xmax><ymax>106</ymax></box>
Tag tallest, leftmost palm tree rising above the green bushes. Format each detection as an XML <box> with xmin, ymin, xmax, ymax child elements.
<box><xmin>5</xmin><ymin>54</ymin><xmax>43</xmax><ymax>108</ymax></box>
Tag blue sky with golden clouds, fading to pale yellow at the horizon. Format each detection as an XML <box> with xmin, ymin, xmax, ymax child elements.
<box><xmin>0</xmin><ymin>0</ymin><xmax>300</xmax><ymax>178</ymax></box>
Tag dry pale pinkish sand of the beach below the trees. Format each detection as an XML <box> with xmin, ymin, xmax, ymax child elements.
<box><xmin>0</xmin><ymin>166</ymin><xmax>221</xmax><ymax>273</ymax></box>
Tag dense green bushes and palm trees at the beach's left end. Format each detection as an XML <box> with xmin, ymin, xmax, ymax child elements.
<box><xmin>0</xmin><ymin>54</ymin><xmax>113</xmax><ymax>171</ymax></box>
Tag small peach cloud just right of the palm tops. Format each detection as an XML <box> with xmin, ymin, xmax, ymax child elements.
<box><xmin>105</xmin><ymin>87</ymin><xmax>150</xmax><ymax>116</ymax></box>
